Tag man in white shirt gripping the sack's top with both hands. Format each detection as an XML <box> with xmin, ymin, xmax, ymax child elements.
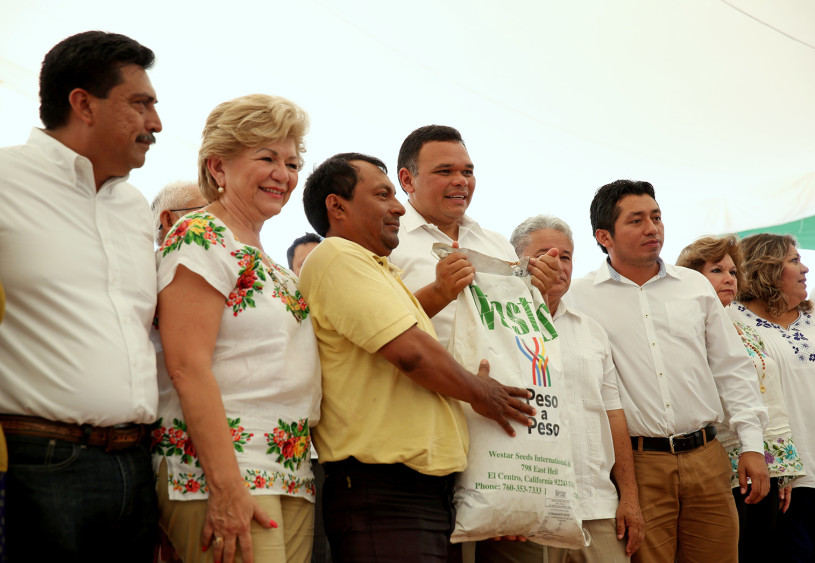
<box><xmin>390</xmin><ymin>125</ymin><xmax>560</xmax><ymax>563</ymax></box>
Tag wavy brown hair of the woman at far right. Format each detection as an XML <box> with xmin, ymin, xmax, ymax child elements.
<box><xmin>736</xmin><ymin>233</ymin><xmax>813</xmax><ymax>317</ymax></box>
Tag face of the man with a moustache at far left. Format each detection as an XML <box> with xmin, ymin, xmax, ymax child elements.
<box><xmin>88</xmin><ymin>64</ymin><xmax>161</xmax><ymax>179</ymax></box>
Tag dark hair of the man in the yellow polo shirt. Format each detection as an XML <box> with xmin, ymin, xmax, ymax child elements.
<box><xmin>303</xmin><ymin>152</ymin><xmax>388</xmax><ymax>237</ymax></box>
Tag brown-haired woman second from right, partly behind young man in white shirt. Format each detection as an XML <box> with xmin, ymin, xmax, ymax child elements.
<box><xmin>677</xmin><ymin>235</ymin><xmax>804</xmax><ymax>561</ymax></box>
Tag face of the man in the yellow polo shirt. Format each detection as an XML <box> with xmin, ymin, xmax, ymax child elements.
<box><xmin>342</xmin><ymin>160</ymin><xmax>405</xmax><ymax>256</ymax></box>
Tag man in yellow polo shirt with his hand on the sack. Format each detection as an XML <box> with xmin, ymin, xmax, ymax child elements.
<box><xmin>300</xmin><ymin>153</ymin><xmax>534</xmax><ymax>561</ymax></box>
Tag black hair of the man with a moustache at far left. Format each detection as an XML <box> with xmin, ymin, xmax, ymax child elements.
<box><xmin>40</xmin><ymin>31</ymin><xmax>155</xmax><ymax>130</ymax></box>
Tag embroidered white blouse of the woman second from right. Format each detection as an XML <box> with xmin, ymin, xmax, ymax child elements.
<box><xmin>720</xmin><ymin>302</ymin><xmax>804</xmax><ymax>487</ymax></box>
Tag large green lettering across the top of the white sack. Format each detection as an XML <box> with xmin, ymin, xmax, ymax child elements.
<box><xmin>470</xmin><ymin>284</ymin><xmax>557</xmax><ymax>340</ymax></box>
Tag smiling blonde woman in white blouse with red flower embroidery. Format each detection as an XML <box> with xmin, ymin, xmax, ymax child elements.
<box><xmin>153</xmin><ymin>94</ymin><xmax>320</xmax><ymax>562</ymax></box>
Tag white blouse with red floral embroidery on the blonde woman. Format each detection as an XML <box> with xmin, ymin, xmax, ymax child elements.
<box><xmin>152</xmin><ymin>212</ymin><xmax>321</xmax><ymax>501</ymax></box>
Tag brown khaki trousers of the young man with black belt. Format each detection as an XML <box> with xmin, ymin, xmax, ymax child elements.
<box><xmin>631</xmin><ymin>439</ymin><xmax>739</xmax><ymax>563</ymax></box>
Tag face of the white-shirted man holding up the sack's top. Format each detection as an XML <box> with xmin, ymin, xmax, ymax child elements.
<box><xmin>399</xmin><ymin>141</ymin><xmax>475</xmax><ymax>239</ymax></box>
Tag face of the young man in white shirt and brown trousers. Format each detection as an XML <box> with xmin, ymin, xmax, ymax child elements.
<box><xmin>595</xmin><ymin>194</ymin><xmax>665</xmax><ymax>277</ymax></box>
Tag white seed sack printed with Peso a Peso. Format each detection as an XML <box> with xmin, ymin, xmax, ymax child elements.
<box><xmin>433</xmin><ymin>243</ymin><xmax>588</xmax><ymax>548</ymax></box>
